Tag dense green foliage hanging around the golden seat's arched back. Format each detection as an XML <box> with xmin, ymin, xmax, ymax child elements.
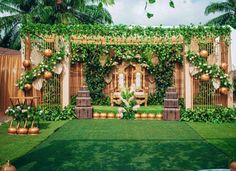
<box><xmin>72</xmin><ymin>44</ymin><xmax>183</xmax><ymax>104</ymax></box>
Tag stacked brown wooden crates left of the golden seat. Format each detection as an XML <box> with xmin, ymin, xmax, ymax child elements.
<box><xmin>75</xmin><ymin>86</ymin><xmax>93</xmax><ymax>119</ymax></box>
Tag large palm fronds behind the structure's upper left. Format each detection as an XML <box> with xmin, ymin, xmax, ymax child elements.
<box><xmin>0</xmin><ymin>0</ymin><xmax>114</xmax><ymax>49</ymax></box>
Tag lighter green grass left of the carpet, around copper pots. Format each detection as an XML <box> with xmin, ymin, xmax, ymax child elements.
<box><xmin>0</xmin><ymin>121</ymin><xmax>67</xmax><ymax>165</ymax></box>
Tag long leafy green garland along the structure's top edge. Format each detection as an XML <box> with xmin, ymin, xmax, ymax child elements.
<box><xmin>21</xmin><ymin>24</ymin><xmax>230</xmax><ymax>44</ymax></box>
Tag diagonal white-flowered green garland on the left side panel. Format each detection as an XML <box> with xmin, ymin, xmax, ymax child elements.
<box><xmin>17</xmin><ymin>48</ymin><xmax>65</xmax><ymax>90</ymax></box>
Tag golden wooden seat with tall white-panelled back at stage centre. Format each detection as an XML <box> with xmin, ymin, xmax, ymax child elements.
<box><xmin>111</xmin><ymin>62</ymin><xmax>148</xmax><ymax>106</ymax></box>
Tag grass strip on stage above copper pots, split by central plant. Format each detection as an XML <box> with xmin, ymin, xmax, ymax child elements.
<box><xmin>93</xmin><ymin>105</ymin><xmax>163</xmax><ymax>114</ymax></box>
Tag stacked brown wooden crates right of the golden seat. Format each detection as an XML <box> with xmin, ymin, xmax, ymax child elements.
<box><xmin>163</xmin><ymin>87</ymin><xmax>180</xmax><ymax>120</ymax></box>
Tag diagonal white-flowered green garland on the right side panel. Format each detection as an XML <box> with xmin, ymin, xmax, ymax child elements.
<box><xmin>187</xmin><ymin>51</ymin><xmax>232</xmax><ymax>88</ymax></box>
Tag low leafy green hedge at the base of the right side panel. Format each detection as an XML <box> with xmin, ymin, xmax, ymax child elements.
<box><xmin>181</xmin><ymin>107</ymin><xmax>236</xmax><ymax>123</ymax></box>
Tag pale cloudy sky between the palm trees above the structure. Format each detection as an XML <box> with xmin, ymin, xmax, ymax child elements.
<box><xmin>106</xmin><ymin>0</ymin><xmax>236</xmax><ymax>69</ymax></box>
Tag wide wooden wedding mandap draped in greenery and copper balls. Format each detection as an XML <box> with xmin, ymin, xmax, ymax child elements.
<box><xmin>9</xmin><ymin>24</ymin><xmax>233</xmax><ymax>121</ymax></box>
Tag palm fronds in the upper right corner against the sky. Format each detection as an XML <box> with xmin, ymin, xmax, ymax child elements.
<box><xmin>205</xmin><ymin>0</ymin><xmax>236</xmax><ymax>28</ymax></box>
